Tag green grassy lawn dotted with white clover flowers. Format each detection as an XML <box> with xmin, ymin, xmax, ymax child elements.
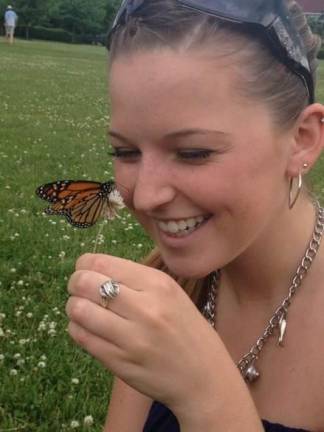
<box><xmin>0</xmin><ymin>38</ymin><xmax>324</xmax><ymax>432</ymax></box>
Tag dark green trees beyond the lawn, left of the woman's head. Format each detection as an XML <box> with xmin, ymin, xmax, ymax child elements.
<box><xmin>0</xmin><ymin>0</ymin><xmax>121</xmax><ymax>39</ymax></box>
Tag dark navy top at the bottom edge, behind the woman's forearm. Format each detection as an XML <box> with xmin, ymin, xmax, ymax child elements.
<box><xmin>143</xmin><ymin>402</ymin><xmax>310</xmax><ymax>432</ymax></box>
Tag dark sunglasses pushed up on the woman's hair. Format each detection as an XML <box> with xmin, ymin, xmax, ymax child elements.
<box><xmin>108</xmin><ymin>0</ymin><xmax>314</xmax><ymax>103</ymax></box>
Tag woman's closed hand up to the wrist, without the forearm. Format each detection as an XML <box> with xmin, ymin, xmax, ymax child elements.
<box><xmin>66</xmin><ymin>254</ymin><xmax>223</xmax><ymax>406</ymax></box>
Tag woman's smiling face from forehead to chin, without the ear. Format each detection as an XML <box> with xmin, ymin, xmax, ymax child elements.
<box><xmin>110</xmin><ymin>49</ymin><xmax>289</xmax><ymax>277</ymax></box>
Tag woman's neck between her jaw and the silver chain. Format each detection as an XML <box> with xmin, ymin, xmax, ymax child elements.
<box><xmin>221</xmin><ymin>200</ymin><xmax>316</xmax><ymax>307</ymax></box>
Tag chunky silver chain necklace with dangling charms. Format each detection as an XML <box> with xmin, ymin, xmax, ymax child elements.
<box><xmin>202</xmin><ymin>202</ymin><xmax>324</xmax><ymax>383</ymax></box>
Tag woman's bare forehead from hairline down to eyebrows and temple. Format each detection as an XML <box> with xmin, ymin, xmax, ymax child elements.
<box><xmin>109</xmin><ymin>49</ymin><xmax>269</xmax><ymax>141</ymax></box>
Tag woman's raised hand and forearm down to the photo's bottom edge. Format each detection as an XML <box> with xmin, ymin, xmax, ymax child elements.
<box><xmin>66</xmin><ymin>254</ymin><xmax>263</xmax><ymax>432</ymax></box>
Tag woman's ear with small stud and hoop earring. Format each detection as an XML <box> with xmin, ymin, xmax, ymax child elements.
<box><xmin>287</xmin><ymin>103</ymin><xmax>324</xmax><ymax>178</ymax></box>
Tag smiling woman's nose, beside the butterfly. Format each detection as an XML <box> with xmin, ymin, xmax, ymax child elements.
<box><xmin>133</xmin><ymin>160</ymin><xmax>176</xmax><ymax>212</ymax></box>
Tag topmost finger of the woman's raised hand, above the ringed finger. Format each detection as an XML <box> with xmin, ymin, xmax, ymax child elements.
<box><xmin>76</xmin><ymin>254</ymin><xmax>166</xmax><ymax>291</ymax></box>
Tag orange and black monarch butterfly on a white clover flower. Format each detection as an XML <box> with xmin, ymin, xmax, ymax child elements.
<box><xmin>36</xmin><ymin>180</ymin><xmax>124</xmax><ymax>228</ymax></box>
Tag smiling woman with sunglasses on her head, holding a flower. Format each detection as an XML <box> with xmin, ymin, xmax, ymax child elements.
<box><xmin>67</xmin><ymin>0</ymin><xmax>324</xmax><ymax>432</ymax></box>
